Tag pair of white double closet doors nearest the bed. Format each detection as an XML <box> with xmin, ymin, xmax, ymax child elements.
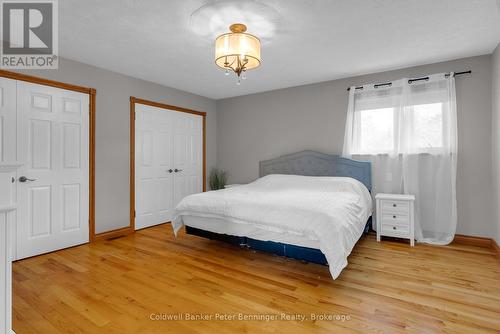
<box><xmin>135</xmin><ymin>103</ymin><xmax>203</xmax><ymax>229</ymax></box>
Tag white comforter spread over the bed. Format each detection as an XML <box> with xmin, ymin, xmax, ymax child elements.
<box><xmin>172</xmin><ymin>175</ymin><xmax>372</xmax><ymax>279</ymax></box>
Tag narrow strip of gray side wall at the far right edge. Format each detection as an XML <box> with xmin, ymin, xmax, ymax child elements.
<box><xmin>491</xmin><ymin>44</ymin><xmax>500</xmax><ymax>245</ymax></box>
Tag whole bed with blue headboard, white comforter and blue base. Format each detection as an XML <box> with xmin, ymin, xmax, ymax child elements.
<box><xmin>172</xmin><ymin>151</ymin><xmax>372</xmax><ymax>279</ymax></box>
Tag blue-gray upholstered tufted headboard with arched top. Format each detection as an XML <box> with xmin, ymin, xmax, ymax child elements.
<box><xmin>259</xmin><ymin>151</ymin><xmax>372</xmax><ymax>191</ymax></box>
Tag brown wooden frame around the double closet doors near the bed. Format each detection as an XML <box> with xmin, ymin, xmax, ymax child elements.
<box><xmin>131</xmin><ymin>96</ymin><xmax>207</xmax><ymax>234</ymax></box>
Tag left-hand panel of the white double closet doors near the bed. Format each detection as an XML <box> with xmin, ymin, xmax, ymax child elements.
<box><xmin>135</xmin><ymin>104</ymin><xmax>175</xmax><ymax>229</ymax></box>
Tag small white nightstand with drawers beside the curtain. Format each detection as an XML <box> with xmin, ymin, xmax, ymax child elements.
<box><xmin>375</xmin><ymin>194</ymin><xmax>415</xmax><ymax>246</ymax></box>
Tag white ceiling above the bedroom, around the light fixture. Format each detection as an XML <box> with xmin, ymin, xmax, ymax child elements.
<box><xmin>59</xmin><ymin>0</ymin><xmax>500</xmax><ymax>99</ymax></box>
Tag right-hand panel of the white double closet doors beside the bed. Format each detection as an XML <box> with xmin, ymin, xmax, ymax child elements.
<box><xmin>174</xmin><ymin>112</ymin><xmax>203</xmax><ymax>206</ymax></box>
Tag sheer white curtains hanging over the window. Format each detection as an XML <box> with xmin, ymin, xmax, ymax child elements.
<box><xmin>343</xmin><ymin>73</ymin><xmax>457</xmax><ymax>245</ymax></box>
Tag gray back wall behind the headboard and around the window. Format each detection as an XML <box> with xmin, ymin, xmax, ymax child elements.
<box><xmin>217</xmin><ymin>55</ymin><xmax>495</xmax><ymax>237</ymax></box>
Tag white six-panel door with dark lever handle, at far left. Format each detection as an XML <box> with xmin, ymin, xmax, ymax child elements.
<box><xmin>16</xmin><ymin>81</ymin><xmax>89</xmax><ymax>259</ymax></box>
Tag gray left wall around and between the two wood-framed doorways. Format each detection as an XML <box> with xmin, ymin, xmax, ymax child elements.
<box><xmin>17</xmin><ymin>59</ymin><xmax>217</xmax><ymax>233</ymax></box>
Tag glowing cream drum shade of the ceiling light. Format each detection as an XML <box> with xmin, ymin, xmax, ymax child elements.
<box><xmin>215</xmin><ymin>32</ymin><xmax>260</xmax><ymax>70</ymax></box>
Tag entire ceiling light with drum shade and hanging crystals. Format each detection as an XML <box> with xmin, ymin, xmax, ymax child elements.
<box><xmin>215</xmin><ymin>23</ymin><xmax>260</xmax><ymax>84</ymax></box>
